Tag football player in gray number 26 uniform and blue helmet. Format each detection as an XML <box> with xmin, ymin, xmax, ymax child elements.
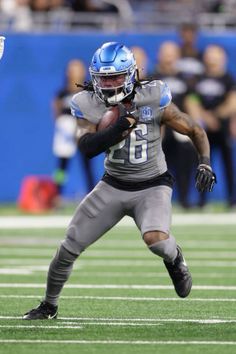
<box><xmin>23</xmin><ymin>42</ymin><xmax>216</xmax><ymax>320</ymax></box>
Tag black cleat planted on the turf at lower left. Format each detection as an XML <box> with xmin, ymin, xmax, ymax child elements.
<box><xmin>23</xmin><ymin>301</ymin><xmax>57</xmax><ymax>320</ymax></box>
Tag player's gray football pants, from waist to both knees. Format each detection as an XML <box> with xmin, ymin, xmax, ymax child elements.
<box><xmin>62</xmin><ymin>181</ymin><xmax>172</xmax><ymax>255</ymax></box>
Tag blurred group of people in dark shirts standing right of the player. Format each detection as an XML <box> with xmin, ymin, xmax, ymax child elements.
<box><xmin>131</xmin><ymin>23</ymin><xmax>236</xmax><ymax>208</ymax></box>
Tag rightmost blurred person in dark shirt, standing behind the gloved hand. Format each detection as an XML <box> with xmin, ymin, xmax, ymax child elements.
<box><xmin>187</xmin><ymin>45</ymin><xmax>236</xmax><ymax>207</ymax></box>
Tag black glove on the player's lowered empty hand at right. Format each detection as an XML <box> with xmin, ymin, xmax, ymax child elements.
<box><xmin>195</xmin><ymin>164</ymin><xmax>217</xmax><ymax>192</ymax></box>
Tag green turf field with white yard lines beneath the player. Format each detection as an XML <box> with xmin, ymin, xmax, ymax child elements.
<box><xmin>0</xmin><ymin>214</ymin><xmax>236</xmax><ymax>354</ymax></box>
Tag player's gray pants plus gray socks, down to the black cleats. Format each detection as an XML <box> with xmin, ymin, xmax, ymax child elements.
<box><xmin>45</xmin><ymin>181</ymin><xmax>176</xmax><ymax>305</ymax></box>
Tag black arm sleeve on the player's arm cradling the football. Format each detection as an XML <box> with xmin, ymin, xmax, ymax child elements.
<box><xmin>78</xmin><ymin>117</ymin><xmax>130</xmax><ymax>158</ymax></box>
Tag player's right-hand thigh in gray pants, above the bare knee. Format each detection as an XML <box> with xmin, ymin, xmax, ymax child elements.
<box><xmin>134</xmin><ymin>186</ymin><xmax>172</xmax><ymax>235</ymax></box>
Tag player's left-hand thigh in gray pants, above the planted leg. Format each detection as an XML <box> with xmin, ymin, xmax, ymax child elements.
<box><xmin>63</xmin><ymin>182</ymin><xmax>124</xmax><ymax>254</ymax></box>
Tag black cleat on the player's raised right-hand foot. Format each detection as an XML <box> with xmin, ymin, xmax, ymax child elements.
<box><xmin>164</xmin><ymin>246</ymin><xmax>192</xmax><ymax>297</ymax></box>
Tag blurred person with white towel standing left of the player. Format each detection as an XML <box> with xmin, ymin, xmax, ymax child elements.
<box><xmin>53</xmin><ymin>60</ymin><xmax>95</xmax><ymax>201</ymax></box>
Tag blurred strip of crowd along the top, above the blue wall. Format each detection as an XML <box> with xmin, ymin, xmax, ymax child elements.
<box><xmin>0</xmin><ymin>0</ymin><xmax>236</xmax><ymax>31</ymax></box>
